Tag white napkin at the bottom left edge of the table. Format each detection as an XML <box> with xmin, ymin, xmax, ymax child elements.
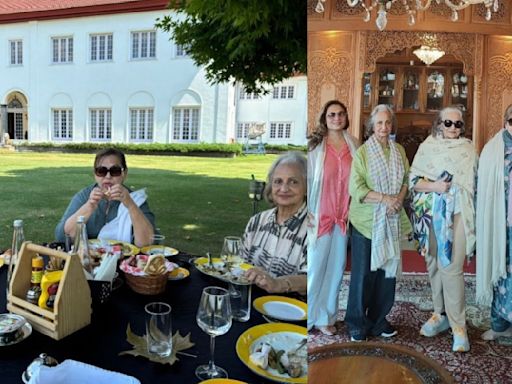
<box><xmin>28</xmin><ymin>359</ymin><xmax>140</xmax><ymax>384</ymax></box>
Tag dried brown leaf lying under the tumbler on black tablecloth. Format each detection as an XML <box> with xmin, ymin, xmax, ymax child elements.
<box><xmin>119</xmin><ymin>324</ymin><xmax>194</xmax><ymax>365</ymax></box>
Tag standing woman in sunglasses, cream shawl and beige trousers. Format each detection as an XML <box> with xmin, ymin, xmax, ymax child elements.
<box><xmin>409</xmin><ymin>107</ymin><xmax>478</xmax><ymax>352</ymax></box>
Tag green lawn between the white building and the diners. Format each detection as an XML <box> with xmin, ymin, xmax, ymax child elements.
<box><xmin>0</xmin><ymin>153</ymin><xmax>276</xmax><ymax>254</ymax></box>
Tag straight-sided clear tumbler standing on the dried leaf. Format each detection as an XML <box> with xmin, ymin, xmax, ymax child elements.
<box><xmin>144</xmin><ymin>302</ymin><xmax>172</xmax><ymax>357</ymax></box>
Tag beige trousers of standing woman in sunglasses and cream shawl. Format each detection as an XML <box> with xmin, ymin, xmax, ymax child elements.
<box><xmin>425</xmin><ymin>214</ymin><xmax>466</xmax><ymax>328</ymax></box>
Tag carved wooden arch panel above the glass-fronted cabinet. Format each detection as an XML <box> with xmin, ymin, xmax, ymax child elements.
<box><xmin>360</xmin><ymin>31</ymin><xmax>481</xmax><ymax>76</ymax></box>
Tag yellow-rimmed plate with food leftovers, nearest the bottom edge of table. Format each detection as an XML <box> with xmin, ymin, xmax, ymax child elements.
<box><xmin>236</xmin><ymin>323</ymin><xmax>308</xmax><ymax>384</ymax></box>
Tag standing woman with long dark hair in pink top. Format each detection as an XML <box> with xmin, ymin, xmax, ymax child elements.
<box><xmin>308</xmin><ymin>100</ymin><xmax>358</xmax><ymax>335</ymax></box>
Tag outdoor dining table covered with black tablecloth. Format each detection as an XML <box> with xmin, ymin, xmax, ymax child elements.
<box><xmin>0</xmin><ymin>252</ymin><xmax>305</xmax><ymax>384</ymax></box>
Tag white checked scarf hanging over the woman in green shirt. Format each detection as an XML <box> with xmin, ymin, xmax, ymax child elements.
<box><xmin>365</xmin><ymin>135</ymin><xmax>405</xmax><ymax>277</ymax></box>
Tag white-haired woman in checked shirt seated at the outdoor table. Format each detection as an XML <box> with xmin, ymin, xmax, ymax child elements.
<box><xmin>242</xmin><ymin>152</ymin><xmax>307</xmax><ymax>295</ymax></box>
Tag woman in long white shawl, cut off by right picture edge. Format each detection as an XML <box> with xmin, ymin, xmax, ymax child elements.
<box><xmin>476</xmin><ymin>105</ymin><xmax>512</xmax><ymax>340</ymax></box>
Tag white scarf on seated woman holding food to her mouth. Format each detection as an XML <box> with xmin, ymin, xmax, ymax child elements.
<box><xmin>98</xmin><ymin>188</ymin><xmax>147</xmax><ymax>243</ymax></box>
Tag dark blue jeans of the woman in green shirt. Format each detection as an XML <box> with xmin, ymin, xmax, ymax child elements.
<box><xmin>345</xmin><ymin>227</ymin><xmax>396</xmax><ymax>339</ymax></box>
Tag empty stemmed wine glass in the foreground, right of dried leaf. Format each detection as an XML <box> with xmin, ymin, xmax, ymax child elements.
<box><xmin>196</xmin><ymin>287</ymin><xmax>232</xmax><ymax>380</ymax></box>
